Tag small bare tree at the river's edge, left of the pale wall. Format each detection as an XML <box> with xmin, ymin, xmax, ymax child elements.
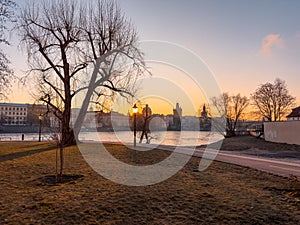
<box><xmin>212</xmin><ymin>93</ymin><xmax>249</xmax><ymax>137</ymax></box>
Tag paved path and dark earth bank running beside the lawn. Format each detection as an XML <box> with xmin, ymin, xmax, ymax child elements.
<box><xmin>116</xmin><ymin>136</ymin><xmax>300</xmax><ymax>178</ymax></box>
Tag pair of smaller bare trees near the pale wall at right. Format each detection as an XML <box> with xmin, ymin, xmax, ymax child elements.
<box><xmin>211</xmin><ymin>78</ymin><xmax>296</xmax><ymax>137</ymax></box>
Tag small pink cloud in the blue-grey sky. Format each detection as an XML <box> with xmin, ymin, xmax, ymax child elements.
<box><xmin>260</xmin><ymin>34</ymin><xmax>283</xmax><ymax>57</ymax></box>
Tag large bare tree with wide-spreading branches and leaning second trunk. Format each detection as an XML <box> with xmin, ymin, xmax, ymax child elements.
<box><xmin>18</xmin><ymin>0</ymin><xmax>145</xmax><ymax>145</ymax></box>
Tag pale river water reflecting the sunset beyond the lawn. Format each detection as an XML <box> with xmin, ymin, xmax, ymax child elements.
<box><xmin>0</xmin><ymin>131</ymin><xmax>222</xmax><ymax>146</ymax></box>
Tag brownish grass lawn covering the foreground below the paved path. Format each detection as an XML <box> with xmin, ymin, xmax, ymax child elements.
<box><xmin>0</xmin><ymin>142</ymin><xmax>300</xmax><ymax>225</ymax></box>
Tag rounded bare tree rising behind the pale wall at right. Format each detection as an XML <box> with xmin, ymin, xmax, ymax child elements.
<box><xmin>251</xmin><ymin>78</ymin><xmax>296</xmax><ymax>121</ymax></box>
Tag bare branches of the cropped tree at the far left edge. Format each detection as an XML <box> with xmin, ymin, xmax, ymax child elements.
<box><xmin>0</xmin><ymin>0</ymin><xmax>16</xmax><ymax>100</ymax></box>
